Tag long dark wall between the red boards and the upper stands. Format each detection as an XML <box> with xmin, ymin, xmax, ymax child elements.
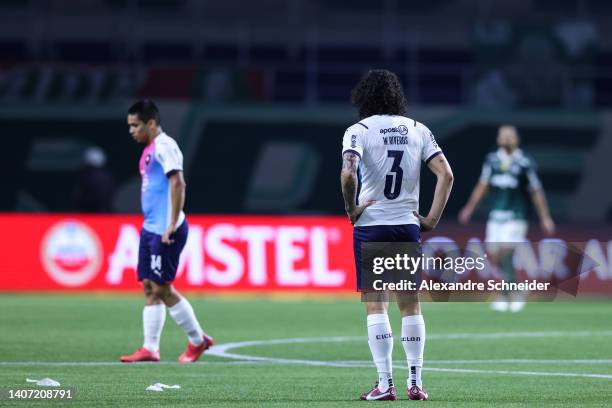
<box><xmin>0</xmin><ymin>110</ymin><xmax>599</xmax><ymax>221</ymax></box>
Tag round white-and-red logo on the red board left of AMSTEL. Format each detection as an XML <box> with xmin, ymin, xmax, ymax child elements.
<box><xmin>40</xmin><ymin>220</ymin><xmax>102</xmax><ymax>287</ymax></box>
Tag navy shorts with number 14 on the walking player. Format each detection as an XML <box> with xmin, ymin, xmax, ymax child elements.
<box><xmin>138</xmin><ymin>220</ymin><xmax>189</xmax><ymax>284</ymax></box>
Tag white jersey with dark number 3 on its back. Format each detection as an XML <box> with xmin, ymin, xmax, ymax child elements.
<box><xmin>342</xmin><ymin>115</ymin><xmax>442</xmax><ymax>227</ymax></box>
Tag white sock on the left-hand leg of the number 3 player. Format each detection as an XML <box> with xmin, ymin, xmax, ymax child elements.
<box><xmin>368</xmin><ymin>314</ymin><xmax>393</xmax><ymax>392</ymax></box>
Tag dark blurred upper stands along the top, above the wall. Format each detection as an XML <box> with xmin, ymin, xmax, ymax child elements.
<box><xmin>0</xmin><ymin>0</ymin><xmax>612</xmax><ymax>109</ymax></box>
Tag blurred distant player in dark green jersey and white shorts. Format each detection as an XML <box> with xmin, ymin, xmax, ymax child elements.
<box><xmin>459</xmin><ymin>125</ymin><xmax>555</xmax><ymax>312</ymax></box>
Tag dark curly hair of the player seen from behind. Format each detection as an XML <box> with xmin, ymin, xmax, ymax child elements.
<box><xmin>351</xmin><ymin>69</ymin><xmax>406</xmax><ymax>119</ymax></box>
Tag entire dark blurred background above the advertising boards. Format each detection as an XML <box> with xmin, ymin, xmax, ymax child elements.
<box><xmin>0</xmin><ymin>0</ymin><xmax>612</xmax><ymax>222</ymax></box>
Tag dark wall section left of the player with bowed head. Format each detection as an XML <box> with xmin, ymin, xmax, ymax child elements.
<box><xmin>0</xmin><ymin>115</ymin><xmax>140</xmax><ymax>211</ymax></box>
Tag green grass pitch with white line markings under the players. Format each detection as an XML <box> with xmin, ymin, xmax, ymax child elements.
<box><xmin>0</xmin><ymin>294</ymin><xmax>612</xmax><ymax>408</ymax></box>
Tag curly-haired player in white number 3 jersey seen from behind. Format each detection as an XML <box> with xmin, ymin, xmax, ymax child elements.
<box><xmin>340</xmin><ymin>70</ymin><xmax>453</xmax><ymax>401</ymax></box>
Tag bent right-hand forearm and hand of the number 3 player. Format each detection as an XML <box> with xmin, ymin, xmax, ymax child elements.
<box><xmin>414</xmin><ymin>154</ymin><xmax>454</xmax><ymax>231</ymax></box>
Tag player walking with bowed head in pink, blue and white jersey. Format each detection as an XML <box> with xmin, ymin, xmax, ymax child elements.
<box><xmin>120</xmin><ymin>100</ymin><xmax>213</xmax><ymax>363</ymax></box>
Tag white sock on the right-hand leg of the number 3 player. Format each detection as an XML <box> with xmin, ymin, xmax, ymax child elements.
<box><xmin>402</xmin><ymin>315</ymin><xmax>425</xmax><ymax>388</ymax></box>
